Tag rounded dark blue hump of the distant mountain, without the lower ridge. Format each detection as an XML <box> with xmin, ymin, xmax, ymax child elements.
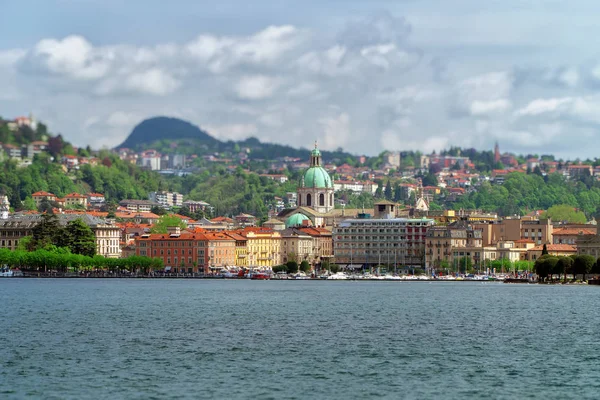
<box><xmin>117</xmin><ymin>117</ymin><xmax>221</xmax><ymax>149</ymax></box>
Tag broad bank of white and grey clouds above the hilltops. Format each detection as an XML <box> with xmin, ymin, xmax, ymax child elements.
<box><xmin>7</xmin><ymin>13</ymin><xmax>600</xmax><ymax>159</ymax></box>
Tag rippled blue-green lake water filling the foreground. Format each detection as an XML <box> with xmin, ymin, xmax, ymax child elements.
<box><xmin>0</xmin><ymin>279</ymin><xmax>600</xmax><ymax>399</ymax></box>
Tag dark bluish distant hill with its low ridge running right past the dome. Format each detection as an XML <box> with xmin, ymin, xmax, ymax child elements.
<box><xmin>117</xmin><ymin>117</ymin><xmax>354</xmax><ymax>160</ymax></box>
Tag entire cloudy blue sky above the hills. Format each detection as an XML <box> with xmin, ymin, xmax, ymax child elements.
<box><xmin>0</xmin><ymin>0</ymin><xmax>600</xmax><ymax>159</ymax></box>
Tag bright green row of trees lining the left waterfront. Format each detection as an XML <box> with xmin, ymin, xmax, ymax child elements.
<box><xmin>0</xmin><ymin>246</ymin><xmax>164</xmax><ymax>273</ymax></box>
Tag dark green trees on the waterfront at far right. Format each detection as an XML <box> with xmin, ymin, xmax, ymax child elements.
<box><xmin>535</xmin><ymin>254</ymin><xmax>600</xmax><ymax>282</ymax></box>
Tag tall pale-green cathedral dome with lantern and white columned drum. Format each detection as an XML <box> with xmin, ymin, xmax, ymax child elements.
<box><xmin>298</xmin><ymin>142</ymin><xmax>334</xmax><ymax>213</ymax></box>
